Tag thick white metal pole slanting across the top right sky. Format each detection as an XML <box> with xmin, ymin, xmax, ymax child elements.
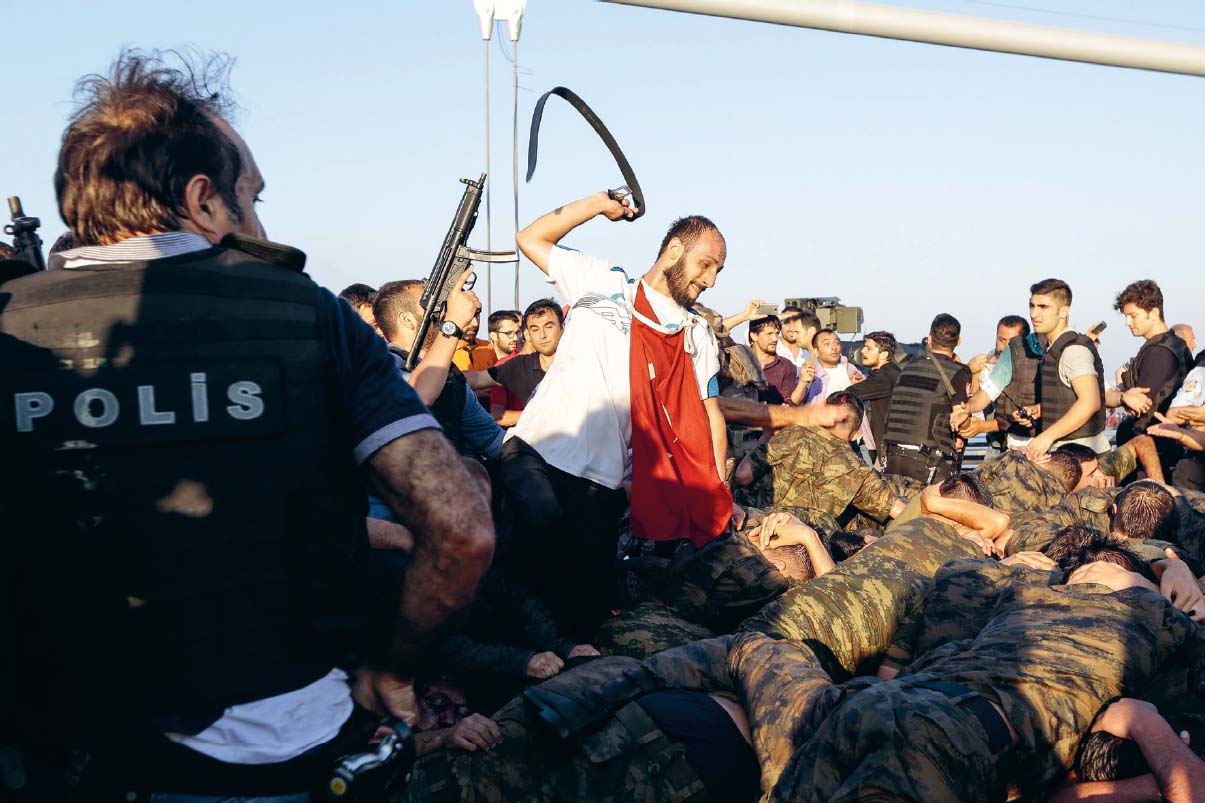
<box><xmin>603</xmin><ymin>0</ymin><xmax>1205</xmax><ymax>77</ymax></box>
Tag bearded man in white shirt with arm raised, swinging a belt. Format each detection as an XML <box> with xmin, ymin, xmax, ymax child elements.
<box><xmin>491</xmin><ymin>192</ymin><xmax>730</xmax><ymax>638</ymax></box>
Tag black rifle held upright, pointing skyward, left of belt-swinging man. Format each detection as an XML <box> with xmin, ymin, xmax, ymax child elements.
<box><xmin>406</xmin><ymin>174</ymin><xmax>519</xmax><ymax>371</ymax></box>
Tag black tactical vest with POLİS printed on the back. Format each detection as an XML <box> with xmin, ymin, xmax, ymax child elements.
<box><xmin>0</xmin><ymin>247</ymin><xmax>378</xmax><ymax>733</ymax></box>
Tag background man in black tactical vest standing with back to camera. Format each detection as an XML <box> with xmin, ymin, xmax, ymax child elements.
<box><xmin>883</xmin><ymin>312</ymin><xmax>971</xmax><ymax>482</ymax></box>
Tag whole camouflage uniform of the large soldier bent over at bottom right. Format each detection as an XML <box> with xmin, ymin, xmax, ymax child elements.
<box><xmin>772</xmin><ymin>570</ymin><xmax>1203</xmax><ymax>802</ymax></box>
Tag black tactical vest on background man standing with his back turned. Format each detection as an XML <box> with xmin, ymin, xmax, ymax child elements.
<box><xmin>883</xmin><ymin>354</ymin><xmax>963</xmax><ymax>456</ymax></box>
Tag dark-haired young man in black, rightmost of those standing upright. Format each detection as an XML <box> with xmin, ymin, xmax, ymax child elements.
<box><xmin>1105</xmin><ymin>279</ymin><xmax>1193</xmax><ymax>476</ymax></box>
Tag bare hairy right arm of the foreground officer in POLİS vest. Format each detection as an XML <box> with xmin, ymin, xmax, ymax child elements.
<box><xmin>369</xmin><ymin>429</ymin><xmax>494</xmax><ymax>673</ymax></box>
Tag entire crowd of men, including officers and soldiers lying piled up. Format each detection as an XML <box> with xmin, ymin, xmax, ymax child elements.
<box><xmin>0</xmin><ymin>52</ymin><xmax>1205</xmax><ymax>803</ymax></box>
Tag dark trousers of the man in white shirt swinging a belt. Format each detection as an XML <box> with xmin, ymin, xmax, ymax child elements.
<box><xmin>501</xmin><ymin>438</ymin><xmax>628</xmax><ymax>643</ymax></box>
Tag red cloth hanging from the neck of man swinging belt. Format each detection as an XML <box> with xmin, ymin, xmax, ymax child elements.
<box><xmin>629</xmin><ymin>285</ymin><xmax>733</xmax><ymax>547</ymax></box>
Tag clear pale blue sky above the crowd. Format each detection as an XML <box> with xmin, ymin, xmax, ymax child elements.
<box><xmin>0</xmin><ymin>0</ymin><xmax>1205</xmax><ymax>373</ymax></box>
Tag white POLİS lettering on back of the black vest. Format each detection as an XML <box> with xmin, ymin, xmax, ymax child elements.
<box><xmin>13</xmin><ymin>373</ymin><xmax>265</xmax><ymax>433</ymax></box>
